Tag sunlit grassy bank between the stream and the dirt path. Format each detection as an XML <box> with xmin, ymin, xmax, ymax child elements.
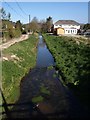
<box><xmin>2</xmin><ymin>35</ymin><xmax>38</xmax><ymax>103</ymax></box>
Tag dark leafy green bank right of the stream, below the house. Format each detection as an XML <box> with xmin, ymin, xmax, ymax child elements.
<box><xmin>43</xmin><ymin>34</ymin><xmax>90</xmax><ymax>106</ymax></box>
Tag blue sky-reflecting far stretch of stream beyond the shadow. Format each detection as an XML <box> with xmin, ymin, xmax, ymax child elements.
<box><xmin>36</xmin><ymin>35</ymin><xmax>54</xmax><ymax>67</ymax></box>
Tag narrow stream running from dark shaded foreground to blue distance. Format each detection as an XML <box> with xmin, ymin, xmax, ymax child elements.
<box><xmin>11</xmin><ymin>35</ymin><xmax>87</xmax><ymax>120</ymax></box>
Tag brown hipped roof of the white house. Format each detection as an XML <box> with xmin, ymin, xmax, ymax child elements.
<box><xmin>54</xmin><ymin>20</ymin><xmax>80</xmax><ymax>25</ymax></box>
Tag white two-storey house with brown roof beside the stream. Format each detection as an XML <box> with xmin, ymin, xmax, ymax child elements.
<box><xmin>54</xmin><ymin>20</ymin><xmax>80</xmax><ymax>35</ymax></box>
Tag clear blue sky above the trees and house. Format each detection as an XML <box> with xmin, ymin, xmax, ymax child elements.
<box><xmin>2</xmin><ymin>0</ymin><xmax>88</xmax><ymax>24</ymax></box>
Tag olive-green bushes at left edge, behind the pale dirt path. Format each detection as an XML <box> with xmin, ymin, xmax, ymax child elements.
<box><xmin>2</xmin><ymin>20</ymin><xmax>23</xmax><ymax>43</ymax></box>
